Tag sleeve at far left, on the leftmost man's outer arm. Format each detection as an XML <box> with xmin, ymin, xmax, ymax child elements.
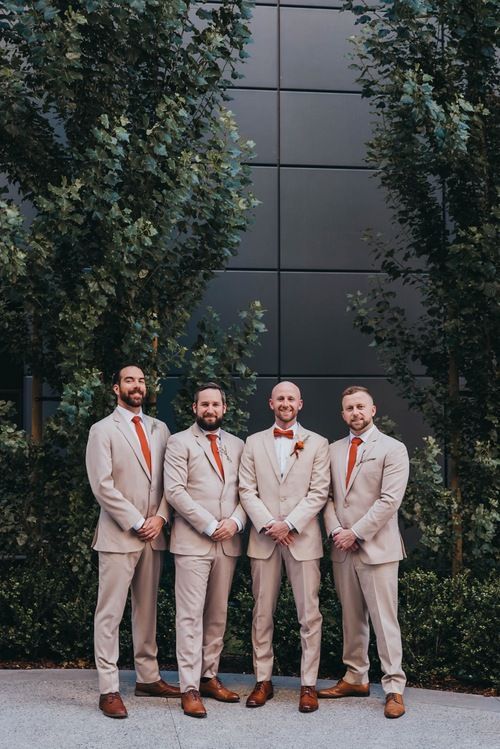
<box><xmin>85</xmin><ymin>424</ymin><xmax>142</xmax><ymax>531</ymax></box>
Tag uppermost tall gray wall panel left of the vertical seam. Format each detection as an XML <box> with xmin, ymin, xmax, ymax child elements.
<box><xmin>238</xmin><ymin>5</ymin><xmax>278</xmax><ymax>88</ymax></box>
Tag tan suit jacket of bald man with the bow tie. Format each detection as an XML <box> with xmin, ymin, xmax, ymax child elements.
<box><xmin>240</xmin><ymin>425</ymin><xmax>330</xmax><ymax>561</ymax></box>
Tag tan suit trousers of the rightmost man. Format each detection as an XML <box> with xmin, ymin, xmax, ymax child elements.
<box><xmin>333</xmin><ymin>553</ymin><xmax>406</xmax><ymax>694</ymax></box>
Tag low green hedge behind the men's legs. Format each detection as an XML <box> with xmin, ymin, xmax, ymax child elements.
<box><xmin>0</xmin><ymin>555</ymin><xmax>500</xmax><ymax>686</ymax></box>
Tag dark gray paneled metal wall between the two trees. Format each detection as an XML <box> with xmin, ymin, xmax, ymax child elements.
<box><xmin>176</xmin><ymin>0</ymin><xmax>434</xmax><ymax>446</ymax></box>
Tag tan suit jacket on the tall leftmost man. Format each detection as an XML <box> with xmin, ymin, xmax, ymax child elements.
<box><xmin>86</xmin><ymin>410</ymin><xmax>170</xmax><ymax>553</ymax></box>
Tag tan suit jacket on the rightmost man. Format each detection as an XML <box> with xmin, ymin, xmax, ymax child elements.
<box><xmin>324</xmin><ymin>427</ymin><xmax>409</xmax><ymax>564</ymax></box>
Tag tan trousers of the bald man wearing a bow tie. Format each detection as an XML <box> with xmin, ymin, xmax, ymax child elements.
<box><xmin>250</xmin><ymin>545</ymin><xmax>323</xmax><ymax>686</ymax></box>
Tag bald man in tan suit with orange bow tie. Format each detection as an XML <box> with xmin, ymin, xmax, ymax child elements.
<box><xmin>240</xmin><ymin>382</ymin><xmax>330</xmax><ymax>713</ymax></box>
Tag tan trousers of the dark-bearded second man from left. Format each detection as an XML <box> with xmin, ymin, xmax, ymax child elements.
<box><xmin>174</xmin><ymin>543</ymin><xmax>237</xmax><ymax>692</ymax></box>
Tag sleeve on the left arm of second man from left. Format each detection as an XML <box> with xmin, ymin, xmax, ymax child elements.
<box><xmin>164</xmin><ymin>435</ymin><xmax>219</xmax><ymax>533</ymax></box>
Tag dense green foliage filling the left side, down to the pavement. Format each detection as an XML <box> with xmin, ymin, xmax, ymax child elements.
<box><xmin>0</xmin><ymin>0</ymin><xmax>254</xmax><ymax>658</ymax></box>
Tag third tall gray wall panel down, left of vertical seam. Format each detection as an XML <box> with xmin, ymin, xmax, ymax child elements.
<box><xmin>230</xmin><ymin>166</ymin><xmax>278</xmax><ymax>268</ymax></box>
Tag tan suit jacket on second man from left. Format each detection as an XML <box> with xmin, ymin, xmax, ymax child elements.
<box><xmin>164</xmin><ymin>424</ymin><xmax>246</xmax><ymax>556</ymax></box>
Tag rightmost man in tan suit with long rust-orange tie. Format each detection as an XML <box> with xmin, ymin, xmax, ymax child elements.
<box><xmin>318</xmin><ymin>386</ymin><xmax>409</xmax><ymax>718</ymax></box>
